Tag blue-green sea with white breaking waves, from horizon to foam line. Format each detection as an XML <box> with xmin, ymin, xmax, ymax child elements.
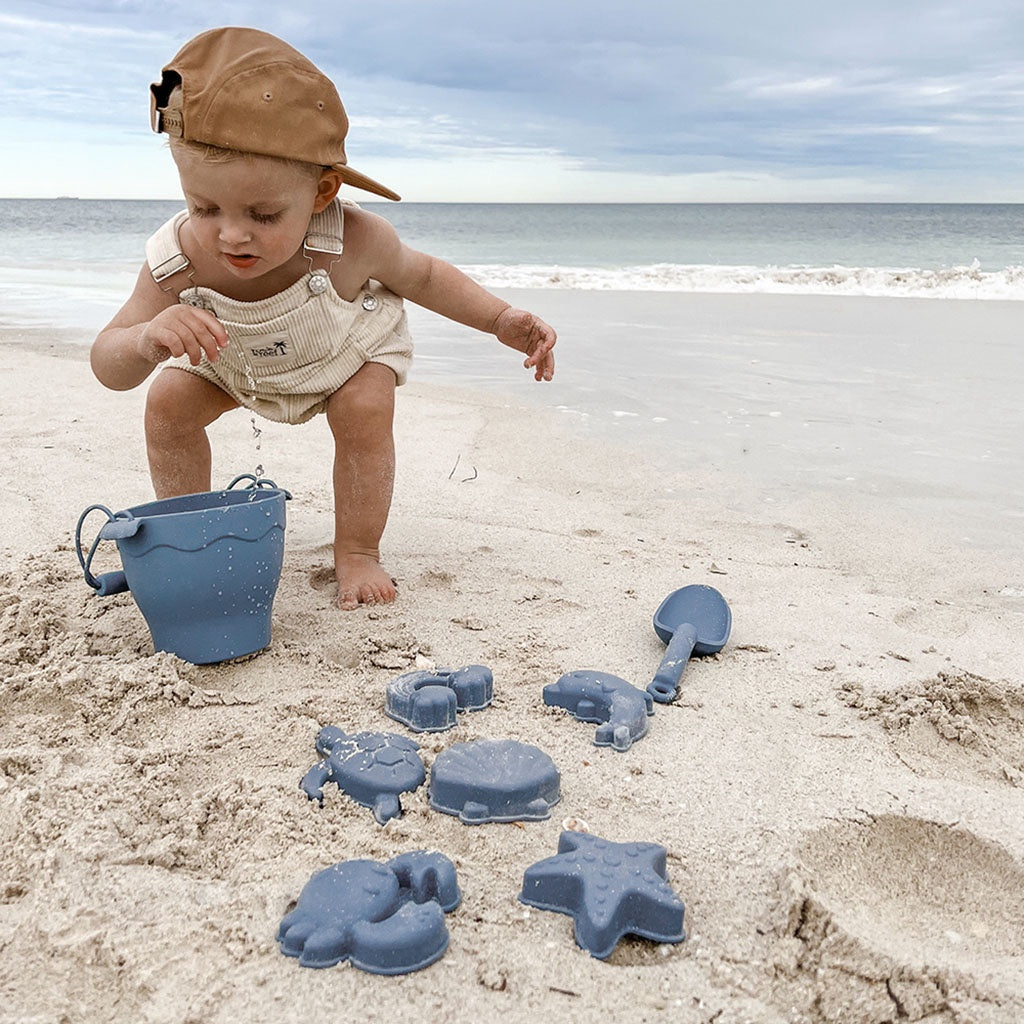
<box><xmin>6</xmin><ymin>199</ymin><xmax>1024</xmax><ymax>315</ymax></box>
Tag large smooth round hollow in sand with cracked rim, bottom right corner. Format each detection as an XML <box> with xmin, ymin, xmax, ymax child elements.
<box><xmin>775</xmin><ymin>816</ymin><xmax>1024</xmax><ymax>1024</ymax></box>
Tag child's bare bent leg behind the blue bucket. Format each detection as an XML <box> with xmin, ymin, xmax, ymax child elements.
<box><xmin>145</xmin><ymin>367</ymin><xmax>238</xmax><ymax>498</ymax></box>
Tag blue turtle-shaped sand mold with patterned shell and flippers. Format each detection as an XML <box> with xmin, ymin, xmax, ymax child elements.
<box><xmin>299</xmin><ymin>725</ymin><xmax>427</xmax><ymax>824</ymax></box>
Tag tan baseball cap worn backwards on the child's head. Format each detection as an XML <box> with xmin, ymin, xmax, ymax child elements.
<box><xmin>150</xmin><ymin>28</ymin><xmax>401</xmax><ymax>200</ymax></box>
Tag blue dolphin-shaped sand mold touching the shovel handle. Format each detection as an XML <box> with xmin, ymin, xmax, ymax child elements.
<box><xmin>544</xmin><ymin>670</ymin><xmax>654</xmax><ymax>751</ymax></box>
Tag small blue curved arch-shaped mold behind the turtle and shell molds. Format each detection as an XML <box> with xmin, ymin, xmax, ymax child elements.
<box><xmin>384</xmin><ymin>665</ymin><xmax>495</xmax><ymax>732</ymax></box>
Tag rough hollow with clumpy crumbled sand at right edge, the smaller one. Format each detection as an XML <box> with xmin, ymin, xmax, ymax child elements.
<box><xmin>839</xmin><ymin>672</ymin><xmax>1024</xmax><ymax>786</ymax></box>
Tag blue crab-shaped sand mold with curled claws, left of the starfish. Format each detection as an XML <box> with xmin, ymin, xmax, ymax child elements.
<box><xmin>278</xmin><ymin>851</ymin><xmax>462</xmax><ymax>974</ymax></box>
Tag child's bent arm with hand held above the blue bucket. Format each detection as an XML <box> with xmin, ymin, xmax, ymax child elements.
<box><xmin>90</xmin><ymin>266</ymin><xmax>227</xmax><ymax>391</ymax></box>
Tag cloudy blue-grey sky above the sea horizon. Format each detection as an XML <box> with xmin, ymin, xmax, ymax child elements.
<box><xmin>6</xmin><ymin>0</ymin><xmax>1024</xmax><ymax>203</ymax></box>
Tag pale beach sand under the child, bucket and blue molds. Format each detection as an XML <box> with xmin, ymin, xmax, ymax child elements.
<box><xmin>0</xmin><ymin>299</ymin><xmax>1024</xmax><ymax>1024</ymax></box>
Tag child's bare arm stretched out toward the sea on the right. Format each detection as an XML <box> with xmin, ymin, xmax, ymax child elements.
<box><xmin>354</xmin><ymin>209</ymin><xmax>557</xmax><ymax>381</ymax></box>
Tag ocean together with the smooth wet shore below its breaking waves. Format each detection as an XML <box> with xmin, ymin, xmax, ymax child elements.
<box><xmin>0</xmin><ymin>199</ymin><xmax>1024</xmax><ymax>546</ymax></box>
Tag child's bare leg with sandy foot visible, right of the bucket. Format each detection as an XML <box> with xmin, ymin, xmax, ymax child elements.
<box><xmin>327</xmin><ymin>362</ymin><xmax>395</xmax><ymax>610</ymax></box>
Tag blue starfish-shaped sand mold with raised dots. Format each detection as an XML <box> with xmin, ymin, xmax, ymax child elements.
<box><xmin>519</xmin><ymin>831</ymin><xmax>686</xmax><ymax>959</ymax></box>
